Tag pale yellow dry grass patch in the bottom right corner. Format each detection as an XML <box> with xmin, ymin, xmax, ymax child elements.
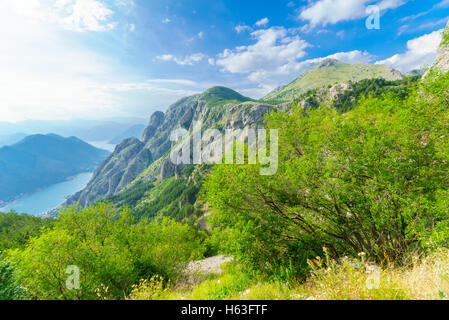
<box><xmin>295</xmin><ymin>250</ymin><xmax>449</xmax><ymax>300</ymax></box>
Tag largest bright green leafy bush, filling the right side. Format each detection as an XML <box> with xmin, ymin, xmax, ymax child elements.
<box><xmin>205</xmin><ymin>70</ymin><xmax>449</xmax><ymax>272</ymax></box>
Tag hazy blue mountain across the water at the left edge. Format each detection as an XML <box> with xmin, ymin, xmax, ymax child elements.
<box><xmin>0</xmin><ymin>134</ymin><xmax>109</xmax><ymax>202</ymax></box>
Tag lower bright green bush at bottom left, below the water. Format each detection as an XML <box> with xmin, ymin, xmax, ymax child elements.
<box><xmin>9</xmin><ymin>203</ymin><xmax>205</xmax><ymax>299</ymax></box>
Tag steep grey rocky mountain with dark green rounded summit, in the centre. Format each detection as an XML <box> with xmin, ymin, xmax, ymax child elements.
<box><xmin>67</xmin><ymin>87</ymin><xmax>273</xmax><ymax>206</ymax></box>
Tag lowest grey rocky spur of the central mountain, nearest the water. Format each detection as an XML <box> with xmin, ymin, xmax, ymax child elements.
<box><xmin>66</xmin><ymin>138</ymin><xmax>152</xmax><ymax>206</ymax></box>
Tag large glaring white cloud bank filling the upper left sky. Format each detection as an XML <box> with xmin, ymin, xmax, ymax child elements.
<box><xmin>0</xmin><ymin>0</ymin><xmax>200</xmax><ymax>121</ymax></box>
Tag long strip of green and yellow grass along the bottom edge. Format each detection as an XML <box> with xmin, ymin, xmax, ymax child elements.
<box><xmin>125</xmin><ymin>249</ymin><xmax>449</xmax><ymax>300</ymax></box>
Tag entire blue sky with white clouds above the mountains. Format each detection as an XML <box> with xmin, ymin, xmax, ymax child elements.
<box><xmin>0</xmin><ymin>0</ymin><xmax>449</xmax><ymax>122</ymax></box>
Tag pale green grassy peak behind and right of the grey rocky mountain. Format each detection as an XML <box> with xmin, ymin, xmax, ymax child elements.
<box><xmin>262</xmin><ymin>59</ymin><xmax>403</xmax><ymax>103</ymax></box>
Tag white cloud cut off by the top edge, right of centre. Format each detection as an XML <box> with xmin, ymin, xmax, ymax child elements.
<box><xmin>299</xmin><ymin>0</ymin><xmax>407</xmax><ymax>26</ymax></box>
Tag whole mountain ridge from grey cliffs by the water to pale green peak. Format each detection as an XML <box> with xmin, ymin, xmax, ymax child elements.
<box><xmin>66</xmin><ymin>59</ymin><xmax>410</xmax><ymax>211</ymax></box>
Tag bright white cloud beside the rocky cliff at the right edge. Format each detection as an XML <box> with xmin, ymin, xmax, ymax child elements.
<box><xmin>376</xmin><ymin>30</ymin><xmax>442</xmax><ymax>72</ymax></box>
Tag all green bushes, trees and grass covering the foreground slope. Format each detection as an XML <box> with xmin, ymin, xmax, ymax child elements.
<box><xmin>0</xmin><ymin>52</ymin><xmax>449</xmax><ymax>300</ymax></box>
